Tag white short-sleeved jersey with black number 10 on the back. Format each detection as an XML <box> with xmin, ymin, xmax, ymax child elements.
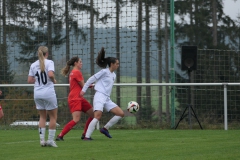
<box><xmin>28</xmin><ymin>59</ymin><xmax>56</xmax><ymax>98</ymax></box>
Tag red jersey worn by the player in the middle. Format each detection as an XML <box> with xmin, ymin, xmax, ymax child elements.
<box><xmin>68</xmin><ymin>70</ymin><xmax>84</xmax><ymax>101</ymax></box>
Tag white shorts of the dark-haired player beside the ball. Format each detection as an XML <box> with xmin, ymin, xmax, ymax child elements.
<box><xmin>93</xmin><ymin>92</ymin><xmax>118</xmax><ymax>112</ymax></box>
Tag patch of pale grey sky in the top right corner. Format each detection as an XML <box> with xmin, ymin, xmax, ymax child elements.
<box><xmin>223</xmin><ymin>0</ymin><xmax>240</xmax><ymax>20</ymax></box>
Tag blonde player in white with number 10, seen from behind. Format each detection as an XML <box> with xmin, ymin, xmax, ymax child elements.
<box><xmin>28</xmin><ymin>46</ymin><xmax>58</xmax><ymax>147</ymax></box>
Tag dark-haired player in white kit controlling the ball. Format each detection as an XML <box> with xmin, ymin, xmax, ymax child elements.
<box><xmin>80</xmin><ymin>48</ymin><xmax>124</xmax><ymax>140</ymax></box>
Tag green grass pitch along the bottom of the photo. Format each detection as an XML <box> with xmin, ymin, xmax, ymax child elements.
<box><xmin>0</xmin><ymin>130</ymin><xmax>240</xmax><ymax>160</ymax></box>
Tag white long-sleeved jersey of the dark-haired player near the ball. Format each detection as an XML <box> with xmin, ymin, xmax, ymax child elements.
<box><xmin>82</xmin><ymin>68</ymin><xmax>116</xmax><ymax>97</ymax></box>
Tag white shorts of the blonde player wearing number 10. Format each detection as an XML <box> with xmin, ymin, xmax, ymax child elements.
<box><xmin>34</xmin><ymin>95</ymin><xmax>58</xmax><ymax>110</ymax></box>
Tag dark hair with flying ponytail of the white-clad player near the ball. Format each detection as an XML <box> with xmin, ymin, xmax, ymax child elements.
<box><xmin>96</xmin><ymin>47</ymin><xmax>117</xmax><ymax>68</ymax></box>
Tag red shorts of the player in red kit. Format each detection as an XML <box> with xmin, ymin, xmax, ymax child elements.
<box><xmin>68</xmin><ymin>98</ymin><xmax>92</xmax><ymax>113</ymax></box>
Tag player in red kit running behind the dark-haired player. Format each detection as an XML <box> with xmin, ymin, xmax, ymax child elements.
<box><xmin>56</xmin><ymin>57</ymin><xmax>93</xmax><ymax>141</ymax></box>
